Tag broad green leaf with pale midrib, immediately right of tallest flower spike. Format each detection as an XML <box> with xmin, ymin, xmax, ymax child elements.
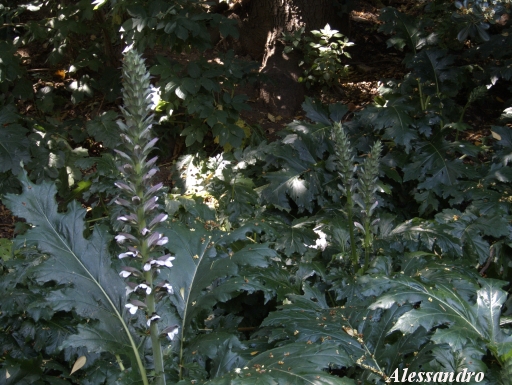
<box><xmin>160</xmin><ymin>222</ymin><xmax>276</xmax><ymax>338</ymax></box>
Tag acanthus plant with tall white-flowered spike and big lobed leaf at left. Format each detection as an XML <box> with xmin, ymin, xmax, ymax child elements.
<box><xmin>3</xmin><ymin>50</ymin><xmax>178</xmax><ymax>385</ymax></box>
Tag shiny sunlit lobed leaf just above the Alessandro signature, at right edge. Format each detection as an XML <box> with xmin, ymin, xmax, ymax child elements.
<box><xmin>370</xmin><ymin>276</ymin><xmax>506</xmax><ymax>349</ymax></box>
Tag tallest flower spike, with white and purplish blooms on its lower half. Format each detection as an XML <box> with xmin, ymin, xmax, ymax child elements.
<box><xmin>116</xmin><ymin>49</ymin><xmax>169</xmax><ymax>385</ymax></box>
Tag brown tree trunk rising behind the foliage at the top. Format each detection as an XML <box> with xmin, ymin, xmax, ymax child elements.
<box><xmin>239</xmin><ymin>0</ymin><xmax>341</xmax><ymax>117</ymax></box>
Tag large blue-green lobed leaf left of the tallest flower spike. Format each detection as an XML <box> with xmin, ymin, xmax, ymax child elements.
<box><xmin>4</xmin><ymin>175</ymin><xmax>138</xmax><ymax>360</ymax></box>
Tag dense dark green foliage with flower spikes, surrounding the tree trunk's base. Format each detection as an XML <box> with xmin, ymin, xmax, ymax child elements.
<box><xmin>0</xmin><ymin>0</ymin><xmax>512</xmax><ymax>385</ymax></box>
